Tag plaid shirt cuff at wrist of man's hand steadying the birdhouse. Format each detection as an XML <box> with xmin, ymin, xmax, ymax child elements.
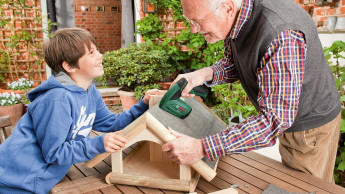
<box><xmin>202</xmin><ymin>133</ymin><xmax>226</xmax><ymax>161</ymax></box>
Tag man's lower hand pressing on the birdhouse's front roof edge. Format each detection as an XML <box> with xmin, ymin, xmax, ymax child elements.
<box><xmin>162</xmin><ymin>128</ymin><xmax>206</xmax><ymax>164</ymax></box>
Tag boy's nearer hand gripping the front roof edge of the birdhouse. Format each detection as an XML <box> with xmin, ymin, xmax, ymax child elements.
<box><xmin>104</xmin><ymin>131</ymin><xmax>128</xmax><ymax>153</ymax></box>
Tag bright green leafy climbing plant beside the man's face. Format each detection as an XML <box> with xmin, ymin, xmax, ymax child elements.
<box><xmin>136</xmin><ymin>0</ymin><xmax>224</xmax><ymax>72</ymax></box>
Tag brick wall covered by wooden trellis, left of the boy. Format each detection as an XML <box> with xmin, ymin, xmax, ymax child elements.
<box><xmin>0</xmin><ymin>0</ymin><xmax>47</xmax><ymax>86</ymax></box>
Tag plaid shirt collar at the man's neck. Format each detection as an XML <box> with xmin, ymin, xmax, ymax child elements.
<box><xmin>228</xmin><ymin>0</ymin><xmax>254</xmax><ymax>39</ymax></box>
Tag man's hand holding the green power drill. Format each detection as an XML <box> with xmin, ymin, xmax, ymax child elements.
<box><xmin>171</xmin><ymin>67</ymin><xmax>213</xmax><ymax>98</ymax></box>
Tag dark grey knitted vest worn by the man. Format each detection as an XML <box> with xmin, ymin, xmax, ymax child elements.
<box><xmin>231</xmin><ymin>0</ymin><xmax>341</xmax><ymax>132</ymax></box>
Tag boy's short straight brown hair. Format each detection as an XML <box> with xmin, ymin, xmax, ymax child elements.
<box><xmin>43</xmin><ymin>28</ymin><xmax>97</xmax><ymax>75</ymax></box>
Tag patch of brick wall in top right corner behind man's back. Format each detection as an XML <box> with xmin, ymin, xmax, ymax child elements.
<box><xmin>294</xmin><ymin>0</ymin><xmax>345</xmax><ymax>27</ymax></box>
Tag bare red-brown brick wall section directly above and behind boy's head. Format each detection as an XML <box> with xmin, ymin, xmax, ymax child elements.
<box><xmin>74</xmin><ymin>0</ymin><xmax>121</xmax><ymax>53</ymax></box>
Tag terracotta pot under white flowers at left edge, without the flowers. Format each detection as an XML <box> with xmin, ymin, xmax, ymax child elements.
<box><xmin>0</xmin><ymin>103</ymin><xmax>25</xmax><ymax>127</ymax></box>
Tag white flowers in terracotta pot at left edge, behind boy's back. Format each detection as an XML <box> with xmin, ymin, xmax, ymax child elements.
<box><xmin>0</xmin><ymin>92</ymin><xmax>24</xmax><ymax>126</ymax></box>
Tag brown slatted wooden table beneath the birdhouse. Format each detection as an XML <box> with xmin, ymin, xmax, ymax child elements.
<box><xmin>51</xmin><ymin>132</ymin><xmax>345</xmax><ymax>194</ymax></box>
